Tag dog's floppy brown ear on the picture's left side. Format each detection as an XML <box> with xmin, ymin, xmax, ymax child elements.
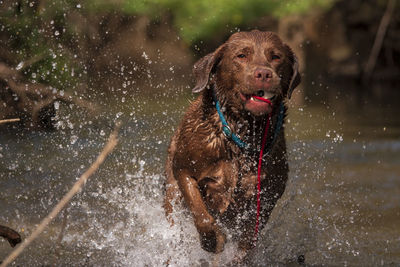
<box><xmin>192</xmin><ymin>45</ymin><xmax>224</xmax><ymax>93</ymax></box>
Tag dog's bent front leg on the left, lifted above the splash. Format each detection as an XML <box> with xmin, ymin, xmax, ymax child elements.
<box><xmin>178</xmin><ymin>171</ymin><xmax>226</xmax><ymax>253</ymax></box>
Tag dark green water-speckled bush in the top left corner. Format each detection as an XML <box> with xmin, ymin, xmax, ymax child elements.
<box><xmin>0</xmin><ymin>1</ymin><xmax>79</xmax><ymax>89</ymax></box>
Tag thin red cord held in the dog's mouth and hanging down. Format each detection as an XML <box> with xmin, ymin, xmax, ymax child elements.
<box><xmin>254</xmin><ymin>96</ymin><xmax>272</xmax><ymax>246</ymax></box>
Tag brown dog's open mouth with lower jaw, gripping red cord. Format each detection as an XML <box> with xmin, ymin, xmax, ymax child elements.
<box><xmin>240</xmin><ymin>90</ymin><xmax>276</xmax><ymax>115</ymax></box>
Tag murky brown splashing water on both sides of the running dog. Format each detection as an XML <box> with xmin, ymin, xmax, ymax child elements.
<box><xmin>0</xmin><ymin>86</ymin><xmax>400</xmax><ymax>266</ymax></box>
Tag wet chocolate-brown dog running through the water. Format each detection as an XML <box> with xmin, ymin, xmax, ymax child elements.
<box><xmin>164</xmin><ymin>31</ymin><xmax>300</xmax><ymax>253</ymax></box>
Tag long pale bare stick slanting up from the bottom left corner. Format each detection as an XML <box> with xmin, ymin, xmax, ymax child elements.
<box><xmin>0</xmin><ymin>123</ymin><xmax>120</xmax><ymax>267</ymax></box>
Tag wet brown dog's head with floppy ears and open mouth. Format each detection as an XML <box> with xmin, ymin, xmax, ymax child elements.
<box><xmin>193</xmin><ymin>30</ymin><xmax>300</xmax><ymax>116</ymax></box>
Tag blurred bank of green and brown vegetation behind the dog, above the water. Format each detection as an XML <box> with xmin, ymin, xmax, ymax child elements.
<box><xmin>0</xmin><ymin>0</ymin><xmax>400</xmax><ymax>126</ymax></box>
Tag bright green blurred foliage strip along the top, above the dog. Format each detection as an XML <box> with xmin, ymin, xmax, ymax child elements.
<box><xmin>91</xmin><ymin>0</ymin><xmax>334</xmax><ymax>43</ymax></box>
